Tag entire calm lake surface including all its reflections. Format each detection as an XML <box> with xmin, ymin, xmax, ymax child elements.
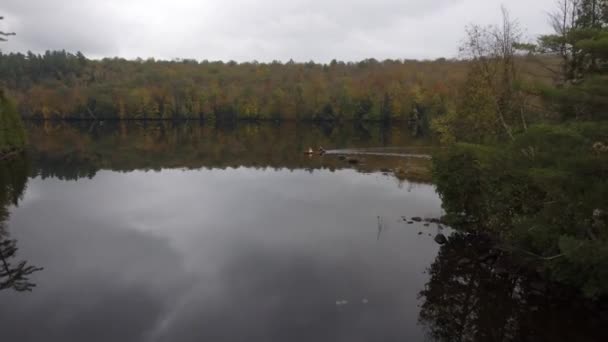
<box><xmin>0</xmin><ymin>123</ymin><xmax>603</xmax><ymax>341</ymax></box>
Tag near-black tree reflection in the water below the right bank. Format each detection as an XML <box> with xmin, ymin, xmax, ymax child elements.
<box><xmin>419</xmin><ymin>234</ymin><xmax>603</xmax><ymax>342</ymax></box>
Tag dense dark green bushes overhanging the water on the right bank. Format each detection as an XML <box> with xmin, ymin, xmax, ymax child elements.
<box><xmin>433</xmin><ymin>122</ymin><xmax>608</xmax><ymax>296</ymax></box>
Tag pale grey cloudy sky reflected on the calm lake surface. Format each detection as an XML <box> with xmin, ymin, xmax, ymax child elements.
<box><xmin>0</xmin><ymin>168</ymin><xmax>440</xmax><ymax>342</ymax></box>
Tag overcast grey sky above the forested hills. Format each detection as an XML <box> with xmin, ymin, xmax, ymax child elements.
<box><xmin>0</xmin><ymin>0</ymin><xmax>555</xmax><ymax>62</ymax></box>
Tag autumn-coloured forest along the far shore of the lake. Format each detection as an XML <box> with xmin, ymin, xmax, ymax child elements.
<box><xmin>0</xmin><ymin>47</ymin><xmax>550</xmax><ymax>134</ymax></box>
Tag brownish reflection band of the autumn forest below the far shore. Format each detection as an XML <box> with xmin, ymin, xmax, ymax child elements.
<box><xmin>29</xmin><ymin>121</ymin><xmax>429</xmax><ymax>183</ymax></box>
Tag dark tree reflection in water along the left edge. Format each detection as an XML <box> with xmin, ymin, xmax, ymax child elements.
<box><xmin>0</xmin><ymin>157</ymin><xmax>41</xmax><ymax>291</ymax></box>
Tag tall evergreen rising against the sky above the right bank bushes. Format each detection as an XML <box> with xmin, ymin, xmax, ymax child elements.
<box><xmin>539</xmin><ymin>0</ymin><xmax>608</xmax><ymax>120</ymax></box>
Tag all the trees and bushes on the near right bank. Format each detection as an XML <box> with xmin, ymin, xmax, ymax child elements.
<box><xmin>434</xmin><ymin>0</ymin><xmax>608</xmax><ymax>298</ymax></box>
